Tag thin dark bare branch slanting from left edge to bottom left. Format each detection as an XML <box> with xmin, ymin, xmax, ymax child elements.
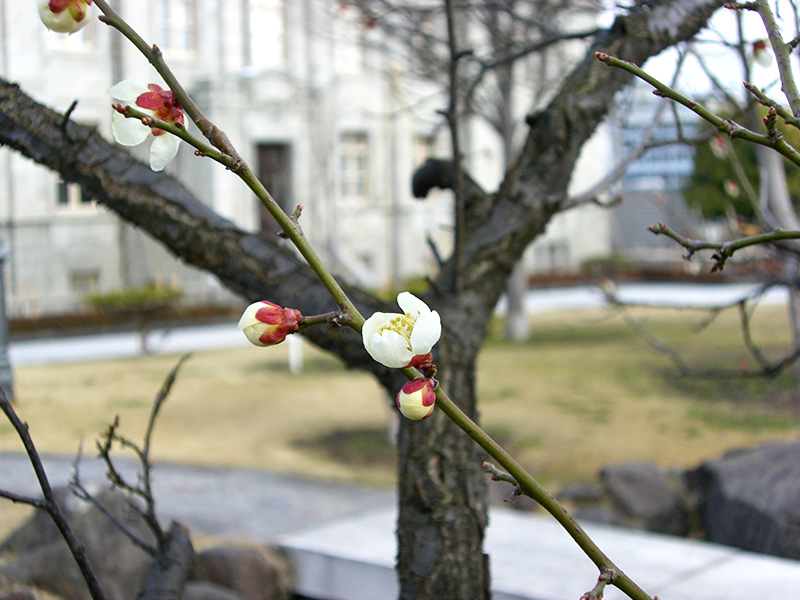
<box><xmin>0</xmin><ymin>388</ymin><xmax>105</xmax><ymax>600</ymax></box>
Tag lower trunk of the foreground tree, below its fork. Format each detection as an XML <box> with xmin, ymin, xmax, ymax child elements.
<box><xmin>397</xmin><ymin>330</ymin><xmax>491</xmax><ymax>600</ymax></box>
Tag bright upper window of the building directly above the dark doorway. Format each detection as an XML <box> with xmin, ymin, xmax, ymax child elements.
<box><xmin>246</xmin><ymin>0</ymin><xmax>286</xmax><ymax>68</ymax></box>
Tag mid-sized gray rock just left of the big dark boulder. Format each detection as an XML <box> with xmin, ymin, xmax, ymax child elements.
<box><xmin>600</xmin><ymin>462</ymin><xmax>689</xmax><ymax>535</ymax></box>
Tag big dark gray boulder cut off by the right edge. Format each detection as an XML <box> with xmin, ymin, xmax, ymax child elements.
<box><xmin>686</xmin><ymin>442</ymin><xmax>800</xmax><ymax>559</ymax></box>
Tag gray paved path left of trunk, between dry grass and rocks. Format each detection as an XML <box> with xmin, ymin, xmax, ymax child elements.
<box><xmin>0</xmin><ymin>453</ymin><xmax>395</xmax><ymax>544</ymax></box>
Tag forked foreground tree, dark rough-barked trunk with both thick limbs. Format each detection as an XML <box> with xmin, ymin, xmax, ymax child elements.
<box><xmin>0</xmin><ymin>0</ymin><xmax>722</xmax><ymax>600</ymax></box>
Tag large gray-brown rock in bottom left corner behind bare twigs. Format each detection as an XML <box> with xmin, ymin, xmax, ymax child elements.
<box><xmin>0</xmin><ymin>488</ymin><xmax>155</xmax><ymax>600</ymax></box>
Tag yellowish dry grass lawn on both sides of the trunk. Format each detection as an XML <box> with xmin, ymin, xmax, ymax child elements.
<box><xmin>0</xmin><ymin>309</ymin><xmax>800</xmax><ymax>536</ymax></box>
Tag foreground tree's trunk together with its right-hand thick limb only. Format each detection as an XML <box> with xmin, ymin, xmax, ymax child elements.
<box><xmin>398</xmin><ymin>0</ymin><xmax>722</xmax><ymax>600</ymax></box>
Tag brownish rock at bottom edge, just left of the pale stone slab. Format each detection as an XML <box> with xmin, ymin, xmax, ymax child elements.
<box><xmin>192</xmin><ymin>546</ymin><xmax>289</xmax><ymax>600</ymax></box>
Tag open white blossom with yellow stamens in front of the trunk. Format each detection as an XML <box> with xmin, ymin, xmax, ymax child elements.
<box><xmin>361</xmin><ymin>292</ymin><xmax>442</xmax><ymax>369</ymax></box>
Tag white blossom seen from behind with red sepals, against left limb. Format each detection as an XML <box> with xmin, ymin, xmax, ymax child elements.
<box><xmin>108</xmin><ymin>79</ymin><xmax>183</xmax><ymax>171</ymax></box>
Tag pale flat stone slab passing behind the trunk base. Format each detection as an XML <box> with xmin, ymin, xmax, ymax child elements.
<box><xmin>280</xmin><ymin>508</ymin><xmax>800</xmax><ymax>600</ymax></box>
